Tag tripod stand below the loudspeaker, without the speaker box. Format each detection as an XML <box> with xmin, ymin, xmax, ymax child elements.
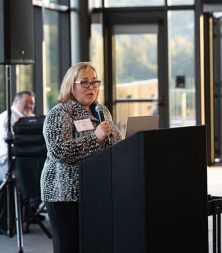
<box><xmin>0</xmin><ymin>65</ymin><xmax>23</xmax><ymax>253</ymax></box>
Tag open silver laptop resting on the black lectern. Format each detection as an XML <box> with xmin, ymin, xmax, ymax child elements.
<box><xmin>125</xmin><ymin>115</ymin><xmax>159</xmax><ymax>138</ymax></box>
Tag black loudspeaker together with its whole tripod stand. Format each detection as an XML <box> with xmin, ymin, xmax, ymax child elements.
<box><xmin>0</xmin><ymin>0</ymin><xmax>34</xmax><ymax>253</ymax></box>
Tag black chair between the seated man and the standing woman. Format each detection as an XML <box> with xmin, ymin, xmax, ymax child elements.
<box><xmin>13</xmin><ymin>116</ymin><xmax>51</xmax><ymax>238</ymax></box>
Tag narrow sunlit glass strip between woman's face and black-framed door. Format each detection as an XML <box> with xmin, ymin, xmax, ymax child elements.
<box><xmin>90</xmin><ymin>24</ymin><xmax>104</xmax><ymax>103</ymax></box>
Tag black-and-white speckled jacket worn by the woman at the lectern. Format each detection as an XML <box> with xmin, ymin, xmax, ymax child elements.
<box><xmin>41</xmin><ymin>100</ymin><xmax>121</xmax><ymax>202</ymax></box>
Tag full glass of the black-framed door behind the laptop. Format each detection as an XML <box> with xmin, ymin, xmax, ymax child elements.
<box><xmin>113</xmin><ymin>31</ymin><xmax>159</xmax><ymax>130</ymax></box>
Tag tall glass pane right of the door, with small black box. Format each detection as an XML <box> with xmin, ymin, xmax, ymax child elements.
<box><xmin>168</xmin><ymin>11</ymin><xmax>196</xmax><ymax>127</ymax></box>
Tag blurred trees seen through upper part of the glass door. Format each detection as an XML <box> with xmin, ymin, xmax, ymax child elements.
<box><xmin>115</xmin><ymin>34</ymin><xmax>157</xmax><ymax>83</ymax></box>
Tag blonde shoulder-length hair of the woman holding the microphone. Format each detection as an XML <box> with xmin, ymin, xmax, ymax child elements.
<box><xmin>58</xmin><ymin>62</ymin><xmax>97</xmax><ymax>102</ymax></box>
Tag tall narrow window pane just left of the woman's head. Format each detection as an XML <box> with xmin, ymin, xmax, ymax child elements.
<box><xmin>43</xmin><ymin>9</ymin><xmax>59</xmax><ymax>113</ymax></box>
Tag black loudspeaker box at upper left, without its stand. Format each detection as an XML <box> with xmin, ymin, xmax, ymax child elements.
<box><xmin>0</xmin><ymin>0</ymin><xmax>34</xmax><ymax>65</ymax></box>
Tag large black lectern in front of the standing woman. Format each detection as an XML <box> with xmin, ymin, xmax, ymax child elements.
<box><xmin>80</xmin><ymin>126</ymin><xmax>208</xmax><ymax>253</ymax></box>
